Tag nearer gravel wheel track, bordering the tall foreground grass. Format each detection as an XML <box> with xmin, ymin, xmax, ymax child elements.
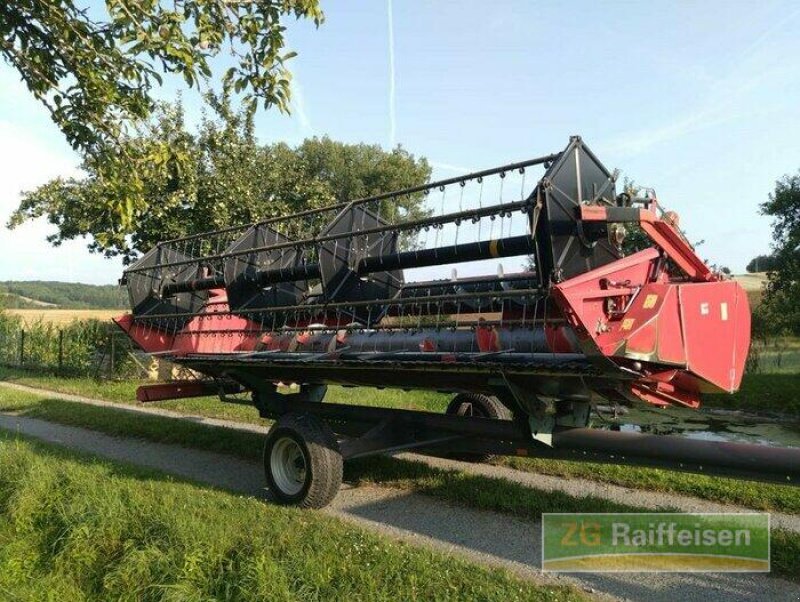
<box><xmin>0</xmin><ymin>414</ymin><xmax>800</xmax><ymax>602</ymax></box>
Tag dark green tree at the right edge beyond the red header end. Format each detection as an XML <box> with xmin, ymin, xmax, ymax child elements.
<box><xmin>761</xmin><ymin>172</ymin><xmax>800</xmax><ymax>334</ymax></box>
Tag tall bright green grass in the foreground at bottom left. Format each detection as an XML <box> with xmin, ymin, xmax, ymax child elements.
<box><xmin>0</xmin><ymin>437</ymin><xmax>585</xmax><ymax>601</ymax></box>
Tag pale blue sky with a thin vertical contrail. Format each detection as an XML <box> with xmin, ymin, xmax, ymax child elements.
<box><xmin>0</xmin><ymin>0</ymin><xmax>800</xmax><ymax>283</ymax></box>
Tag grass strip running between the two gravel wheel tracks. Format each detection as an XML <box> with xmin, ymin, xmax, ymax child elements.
<box><xmin>0</xmin><ymin>391</ymin><xmax>800</xmax><ymax>579</ymax></box>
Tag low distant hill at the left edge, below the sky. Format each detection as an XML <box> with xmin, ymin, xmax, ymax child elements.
<box><xmin>0</xmin><ymin>280</ymin><xmax>127</xmax><ymax>309</ymax></box>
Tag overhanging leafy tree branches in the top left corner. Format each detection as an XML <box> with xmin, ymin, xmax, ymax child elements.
<box><xmin>0</xmin><ymin>0</ymin><xmax>323</xmax><ymax>225</ymax></box>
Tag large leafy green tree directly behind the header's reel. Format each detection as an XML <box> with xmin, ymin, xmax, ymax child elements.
<box><xmin>8</xmin><ymin>98</ymin><xmax>431</xmax><ymax>263</ymax></box>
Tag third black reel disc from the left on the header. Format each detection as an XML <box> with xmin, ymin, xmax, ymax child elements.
<box><xmin>319</xmin><ymin>205</ymin><xmax>403</xmax><ymax>324</ymax></box>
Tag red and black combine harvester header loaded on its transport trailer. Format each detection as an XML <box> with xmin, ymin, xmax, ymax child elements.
<box><xmin>115</xmin><ymin>136</ymin><xmax>800</xmax><ymax>507</ymax></box>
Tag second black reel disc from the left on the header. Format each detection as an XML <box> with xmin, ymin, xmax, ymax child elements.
<box><xmin>223</xmin><ymin>224</ymin><xmax>307</xmax><ymax>319</ymax></box>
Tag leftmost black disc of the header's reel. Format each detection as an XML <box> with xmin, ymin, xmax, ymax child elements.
<box><xmin>126</xmin><ymin>245</ymin><xmax>208</xmax><ymax>331</ymax></box>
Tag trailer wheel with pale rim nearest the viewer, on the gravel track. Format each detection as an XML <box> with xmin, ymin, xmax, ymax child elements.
<box><xmin>264</xmin><ymin>413</ymin><xmax>342</xmax><ymax>508</ymax></box>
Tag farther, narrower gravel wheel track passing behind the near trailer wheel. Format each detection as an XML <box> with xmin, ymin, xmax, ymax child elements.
<box><xmin>0</xmin><ymin>382</ymin><xmax>800</xmax><ymax>533</ymax></box>
